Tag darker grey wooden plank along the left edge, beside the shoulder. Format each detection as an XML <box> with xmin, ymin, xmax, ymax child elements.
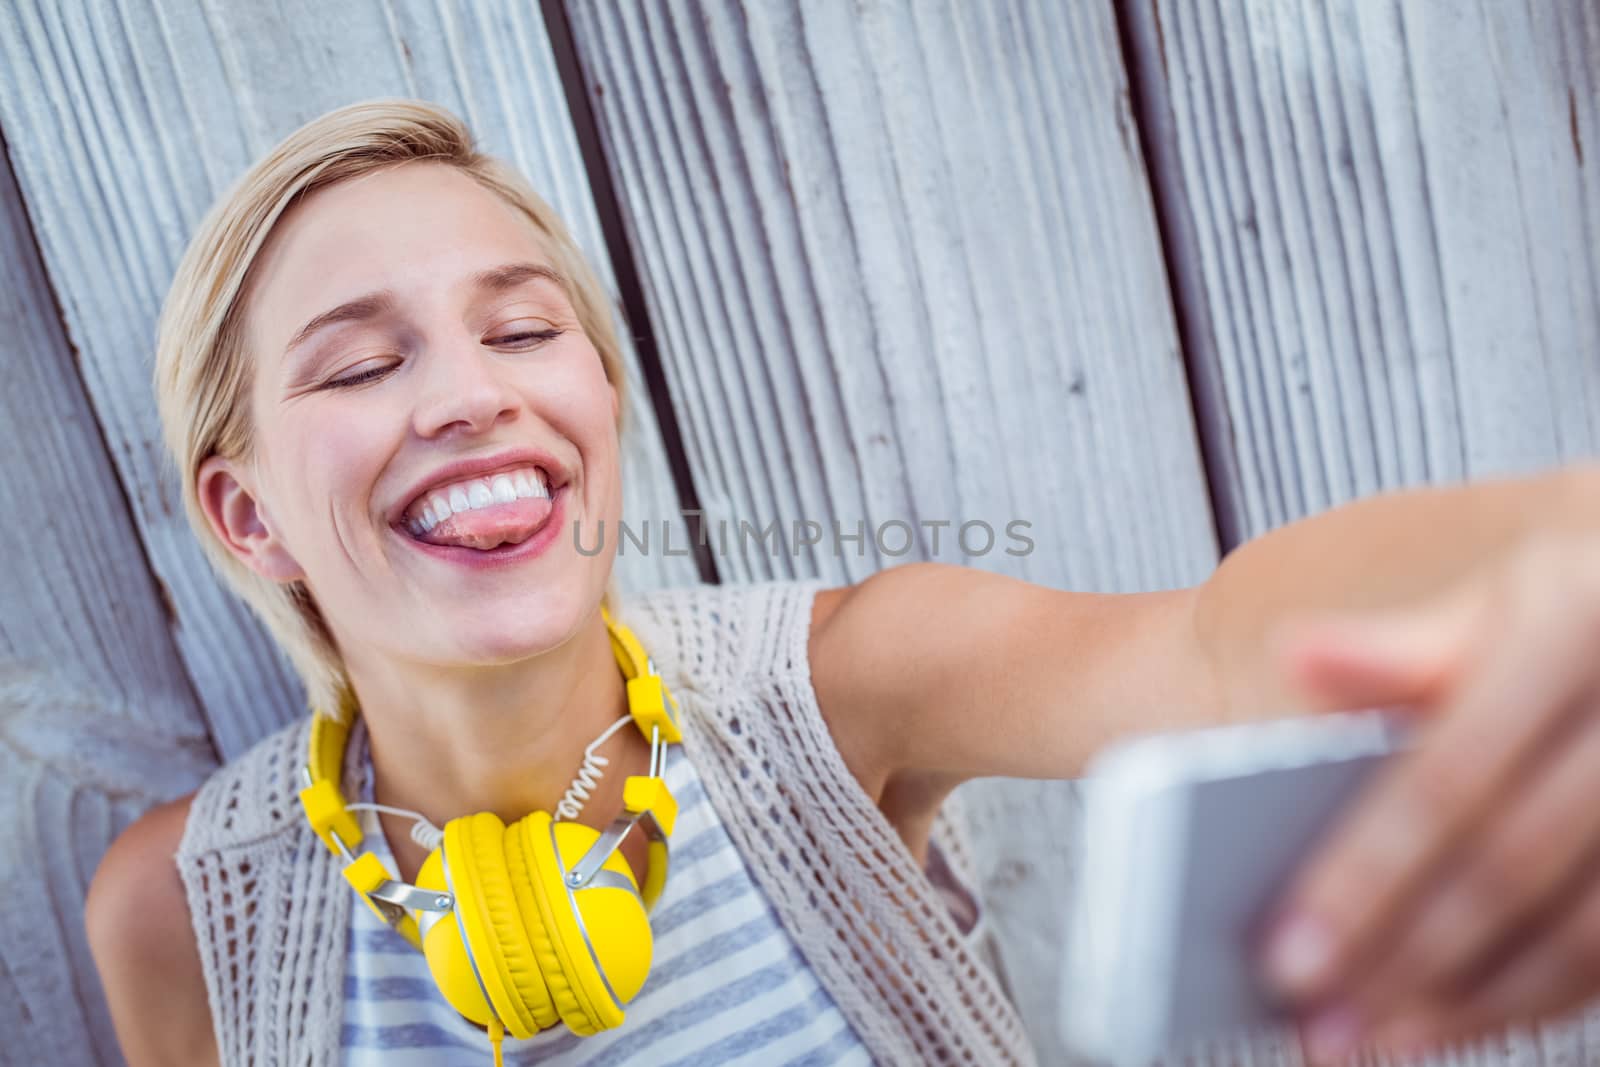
<box><xmin>0</xmin><ymin>129</ymin><xmax>216</xmax><ymax>1065</ymax></box>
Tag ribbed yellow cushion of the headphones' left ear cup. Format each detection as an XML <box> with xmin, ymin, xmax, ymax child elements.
<box><xmin>424</xmin><ymin>813</ymin><xmax>560</xmax><ymax>1038</ymax></box>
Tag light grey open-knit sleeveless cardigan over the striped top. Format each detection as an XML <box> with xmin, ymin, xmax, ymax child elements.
<box><xmin>178</xmin><ymin>581</ymin><xmax>1035</xmax><ymax>1067</ymax></box>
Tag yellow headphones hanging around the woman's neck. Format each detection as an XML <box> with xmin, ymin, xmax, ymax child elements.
<box><xmin>299</xmin><ymin>606</ymin><xmax>682</xmax><ymax>1062</ymax></box>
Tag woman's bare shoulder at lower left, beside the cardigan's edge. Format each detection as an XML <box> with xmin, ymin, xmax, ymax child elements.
<box><xmin>85</xmin><ymin>793</ymin><xmax>216</xmax><ymax>1067</ymax></box>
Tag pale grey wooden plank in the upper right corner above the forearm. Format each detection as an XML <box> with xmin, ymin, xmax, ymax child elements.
<box><xmin>1130</xmin><ymin>0</ymin><xmax>1600</xmax><ymax>547</ymax></box>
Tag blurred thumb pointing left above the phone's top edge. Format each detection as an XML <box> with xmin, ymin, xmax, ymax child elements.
<box><xmin>1272</xmin><ymin>589</ymin><xmax>1483</xmax><ymax>710</ymax></box>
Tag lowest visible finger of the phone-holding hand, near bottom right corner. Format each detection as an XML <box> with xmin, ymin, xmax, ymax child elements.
<box><xmin>1356</xmin><ymin>870</ymin><xmax>1600</xmax><ymax>1054</ymax></box>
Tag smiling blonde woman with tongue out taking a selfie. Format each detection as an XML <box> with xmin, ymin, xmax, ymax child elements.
<box><xmin>86</xmin><ymin>101</ymin><xmax>1600</xmax><ymax>1067</ymax></box>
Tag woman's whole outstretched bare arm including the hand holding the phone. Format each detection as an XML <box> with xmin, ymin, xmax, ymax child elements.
<box><xmin>813</xmin><ymin>464</ymin><xmax>1600</xmax><ymax>1062</ymax></box>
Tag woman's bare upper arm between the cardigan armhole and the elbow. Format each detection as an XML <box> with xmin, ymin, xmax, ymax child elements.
<box><xmin>810</xmin><ymin>563</ymin><xmax>1216</xmax><ymax>795</ymax></box>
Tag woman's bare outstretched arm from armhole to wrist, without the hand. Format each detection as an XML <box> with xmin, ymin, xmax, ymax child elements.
<box><xmin>811</xmin><ymin>464</ymin><xmax>1600</xmax><ymax>793</ymax></box>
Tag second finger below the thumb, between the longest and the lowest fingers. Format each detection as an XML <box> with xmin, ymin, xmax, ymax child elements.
<box><xmin>1355</xmin><ymin>697</ymin><xmax>1600</xmax><ymax>1019</ymax></box>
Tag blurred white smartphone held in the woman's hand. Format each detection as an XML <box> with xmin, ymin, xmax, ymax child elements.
<box><xmin>1061</xmin><ymin>710</ymin><xmax>1411</xmax><ymax>1065</ymax></box>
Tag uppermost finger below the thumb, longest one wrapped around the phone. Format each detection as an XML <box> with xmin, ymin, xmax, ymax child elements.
<box><xmin>1267</xmin><ymin>547</ymin><xmax>1600</xmax><ymax>1000</ymax></box>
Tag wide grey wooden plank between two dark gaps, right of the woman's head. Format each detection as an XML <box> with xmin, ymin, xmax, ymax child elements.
<box><xmin>568</xmin><ymin>0</ymin><xmax>1216</xmax><ymax>1062</ymax></box>
